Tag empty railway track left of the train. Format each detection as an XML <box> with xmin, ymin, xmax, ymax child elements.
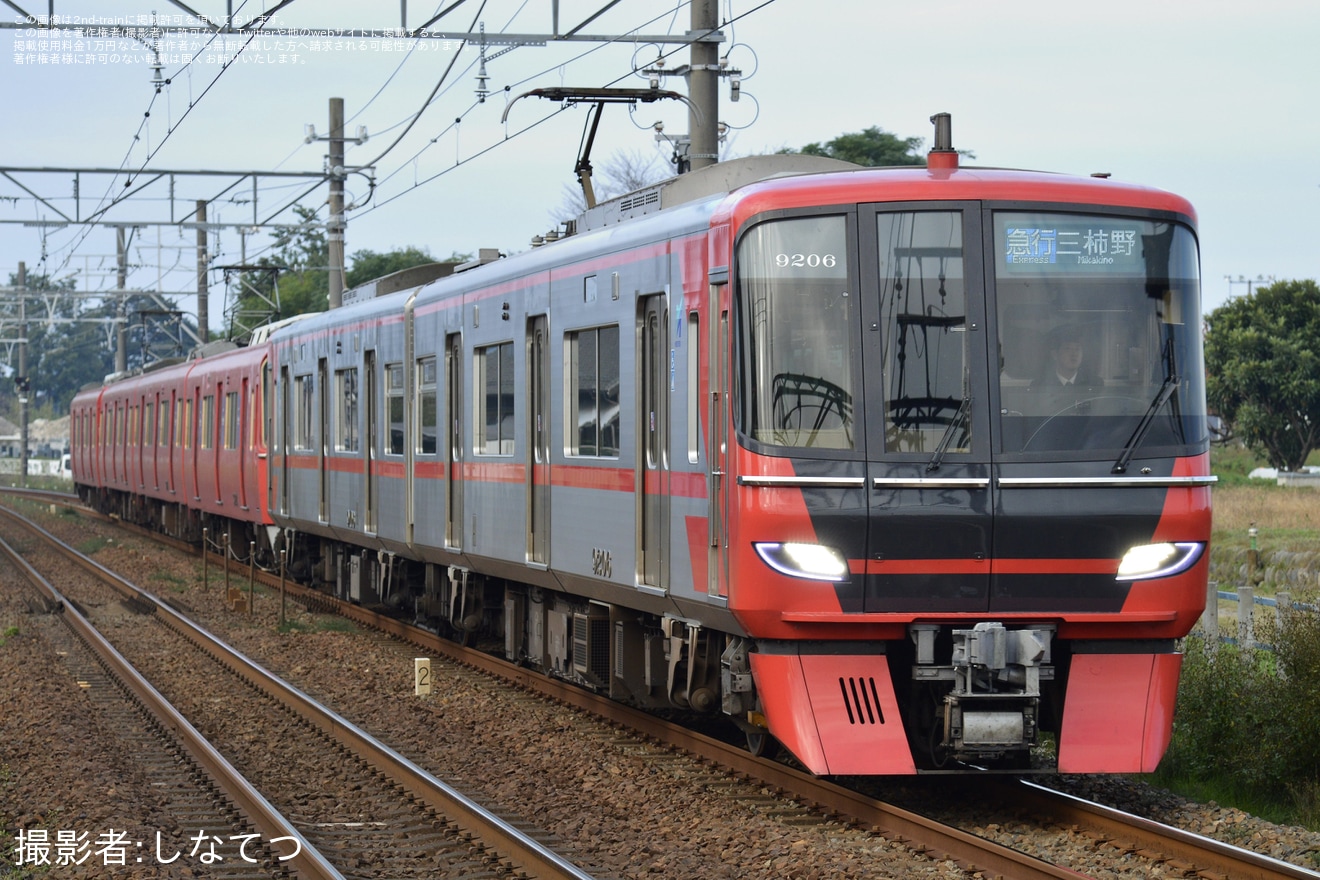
<box><xmin>0</xmin><ymin>501</ymin><xmax>591</xmax><ymax>880</ymax></box>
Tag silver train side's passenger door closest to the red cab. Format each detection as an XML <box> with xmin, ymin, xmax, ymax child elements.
<box><xmin>636</xmin><ymin>294</ymin><xmax>669</xmax><ymax>590</ymax></box>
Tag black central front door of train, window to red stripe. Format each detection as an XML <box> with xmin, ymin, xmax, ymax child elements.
<box><xmin>858</xmin><ymin>204</ymin><xmax>994</xmax><ymax>612</ymax></box>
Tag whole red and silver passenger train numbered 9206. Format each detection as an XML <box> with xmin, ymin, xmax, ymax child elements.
<box><xmin>71</xmin><ymin>118</ymin><xmax>1214</xmax><ymax>776</ymax></box>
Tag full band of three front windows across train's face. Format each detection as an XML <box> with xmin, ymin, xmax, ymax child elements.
<box><xmin>738</xmin><ymin>210</ymin><xmax>1206</xmax><ymax>471</ymax></box>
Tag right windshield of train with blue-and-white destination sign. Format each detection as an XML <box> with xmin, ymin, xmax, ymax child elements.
<box><xmin>994</xmin><ymin>212</ymin><xmax>1206</xmax><ymax>458</ymax></box>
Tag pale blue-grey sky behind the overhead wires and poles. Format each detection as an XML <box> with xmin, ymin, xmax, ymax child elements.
<box><xmin>0</xmin><ymin>0</ymin><xmax>1320</xmax><ymax>340</ymax></box>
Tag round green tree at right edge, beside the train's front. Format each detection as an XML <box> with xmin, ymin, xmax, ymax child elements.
<box><xmin>1205</xmin><ymin>280</ymin><xmax>1320</xmax><ymax>470</ymax></box>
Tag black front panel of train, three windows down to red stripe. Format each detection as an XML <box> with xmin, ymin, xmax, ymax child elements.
<box><xmin>735</xmin><ymin>203</ymin><xmax>1208</xmax><ymax>613</ymax></box>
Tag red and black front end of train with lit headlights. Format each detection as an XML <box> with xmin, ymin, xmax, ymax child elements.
<box><xmin>709</xmin><ymin>124</ymin><xmax>1213</xmax><ymax>774</ymax></box>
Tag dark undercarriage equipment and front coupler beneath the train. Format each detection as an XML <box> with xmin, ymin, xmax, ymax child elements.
<box><xmin>83</xmin><ymin>489</ymin><xmax>1067</xmax><ymax>772</ymax></box>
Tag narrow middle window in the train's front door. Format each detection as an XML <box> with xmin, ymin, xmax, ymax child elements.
<box><xmin>876</xmin><ymin>211</ymin><xmax>973</xmax><ymax>454</ymax></box>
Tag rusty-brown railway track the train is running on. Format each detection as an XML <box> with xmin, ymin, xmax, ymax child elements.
<box><xmin>7</xmin><ymin>493</ymin><xmax>1317</xmax><ymax>879</ymax></box>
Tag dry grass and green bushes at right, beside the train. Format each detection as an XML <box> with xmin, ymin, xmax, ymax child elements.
<box><xmin>1151</xmin><ymin>446</ymin><xmax>1320</xmax><ymax>828</ymax></box>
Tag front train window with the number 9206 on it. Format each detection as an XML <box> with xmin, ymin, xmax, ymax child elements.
<box><xmin>737</xmin><ymin>215</ymin><xmax>858</xmax><ymax>450</ymax></box>
